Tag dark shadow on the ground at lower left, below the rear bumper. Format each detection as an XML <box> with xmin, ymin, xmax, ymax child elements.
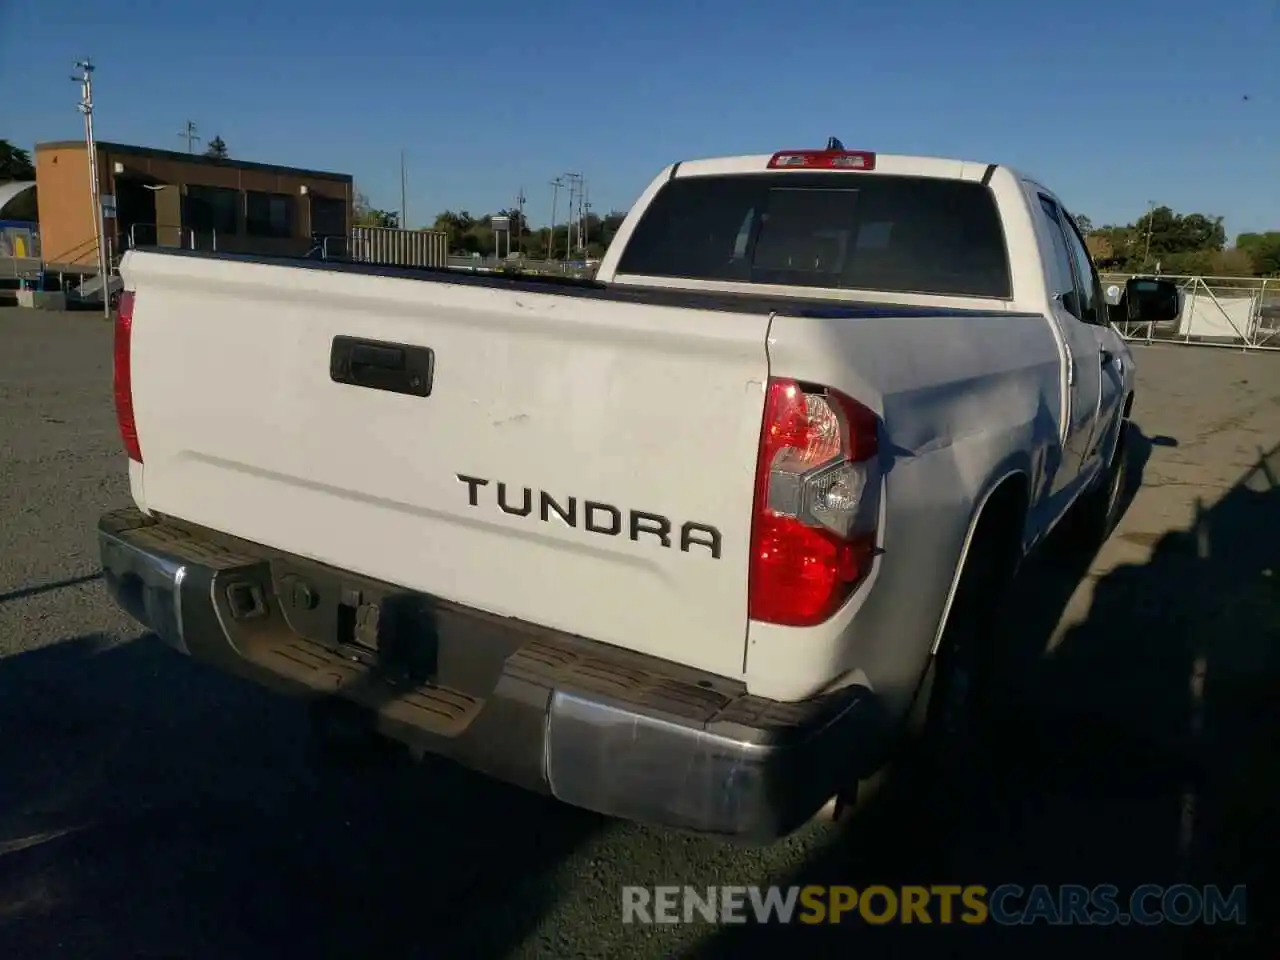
<box><xmin>0</xmin><ymin>636</ymin><xmax>600</xmax><ymax>960</ymax></box>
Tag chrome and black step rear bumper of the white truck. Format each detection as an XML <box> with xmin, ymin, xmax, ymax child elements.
<box><xmin>99</xmin><ymin>509</ymin><xmax>873</xmax><ymax>841</ymax></box>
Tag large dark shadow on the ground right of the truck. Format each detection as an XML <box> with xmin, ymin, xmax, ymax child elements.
<box><xmin>691</xmin><ymin>434</ymin><xmax>1280</xmax><ymax>959</ymax></box>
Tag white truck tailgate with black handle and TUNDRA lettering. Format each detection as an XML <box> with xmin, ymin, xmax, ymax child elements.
<box><xmin>123</xmin><ymin>252</ymin><xmax>769</xmax><ymax>676</ymax></box>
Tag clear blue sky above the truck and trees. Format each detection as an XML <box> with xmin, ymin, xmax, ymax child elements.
<box><xmin>0</xmin><ymin>0</ymin><xmax>1280</xmax><ymax>237</ymax></box>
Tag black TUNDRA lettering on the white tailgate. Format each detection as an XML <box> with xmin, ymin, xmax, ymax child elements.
<box><xmin>457</xmin><ymin>474</ymin><xmax>723</xmax><ymax>559</ymax></box>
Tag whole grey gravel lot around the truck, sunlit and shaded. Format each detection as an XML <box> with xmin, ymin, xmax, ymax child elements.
<box><xmin>0</xmin><ymin>308</ymin><xmax>1280</xmax><ymax>960</ymax></box>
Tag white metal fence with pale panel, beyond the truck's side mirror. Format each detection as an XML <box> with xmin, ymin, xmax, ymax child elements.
<box><xmin>1102</xmin><ymin>274</ymin><xmax>1280</xmax><ymax>351</ymax></box>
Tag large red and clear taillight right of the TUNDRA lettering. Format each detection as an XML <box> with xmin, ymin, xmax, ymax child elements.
<box><xmin>748</xmin><ymin>379</ymin><xmax>879</xmax><ymax>626</ymax></box>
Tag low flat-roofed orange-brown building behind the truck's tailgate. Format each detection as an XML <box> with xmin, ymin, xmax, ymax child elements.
<box><xmin>35</xmin><ymin>141</ymin><xmax>355</xmax><ymax>273</ymax></box>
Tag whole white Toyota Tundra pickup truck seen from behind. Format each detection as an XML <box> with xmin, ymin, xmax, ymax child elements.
<box><xmin>99</xmin><ymin>142</ymin><xmax>1169</xmax><ymax>840</ymax></box>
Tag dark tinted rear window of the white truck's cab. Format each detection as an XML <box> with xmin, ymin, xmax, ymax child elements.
<box><xmin>618</xmin><ymin>172</ymin><xmax>1012</xmax><ymax>300</ymax></box>
